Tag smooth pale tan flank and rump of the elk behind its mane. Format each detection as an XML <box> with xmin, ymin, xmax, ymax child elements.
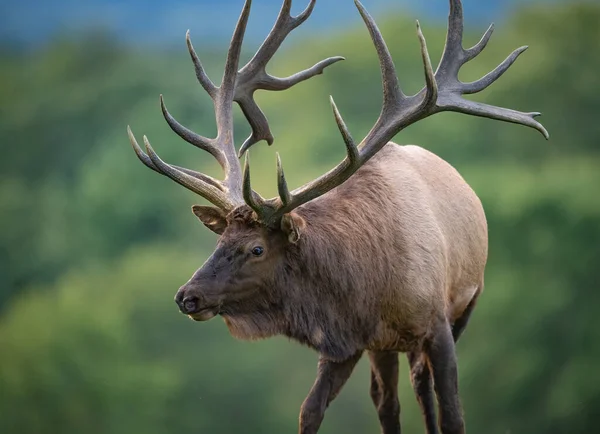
<box><xmin>352</xmin><ymin>144</ymin><xmax>488</xmax><ymax>351</ymax></box>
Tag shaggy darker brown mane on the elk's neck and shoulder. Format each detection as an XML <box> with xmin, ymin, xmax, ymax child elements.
<box><xmin>275</xmin><ymin>161</ymin><xmax>394</xmax><ymax>360</ymax></box>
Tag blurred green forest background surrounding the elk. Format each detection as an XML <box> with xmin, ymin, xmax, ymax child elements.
<box><xmin>0</xmin><ymin>0</ymin><xmax>600</xmax><ymax>434</ymax></box>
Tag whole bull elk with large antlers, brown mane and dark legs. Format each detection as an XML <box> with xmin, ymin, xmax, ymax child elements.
<box><xmin>128</xmin><ymin>0</ymin><xmax>548</xmax><ymax>434</ymax></box>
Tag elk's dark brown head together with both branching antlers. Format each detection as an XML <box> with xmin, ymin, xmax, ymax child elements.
<box><xmin>128</xmin><ymin>0</ymin><xmax>548</xmax><ymax>326</ymax></box>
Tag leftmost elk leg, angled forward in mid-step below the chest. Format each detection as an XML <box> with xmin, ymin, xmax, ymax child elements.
<box><xmin>298</xmin><ymin>352</ymin><xmax>362</xmax><ymax>434</ymax></box>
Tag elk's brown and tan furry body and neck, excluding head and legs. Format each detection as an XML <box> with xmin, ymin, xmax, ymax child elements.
<box><xmin>222</xmin><ymin>143</ymin><xmax>487</xmax><ymax>360</ymax></box>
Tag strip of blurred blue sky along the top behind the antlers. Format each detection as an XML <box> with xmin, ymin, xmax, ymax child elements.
<box><xmin>0</xmin><ymin>0</ymin><xmax>565</xmax><ymax>44</ymax></box>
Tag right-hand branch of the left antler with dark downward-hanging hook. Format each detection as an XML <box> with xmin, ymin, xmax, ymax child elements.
<box><xmin>235</xmin><ymin>0</ymin><xmax>344</xmax><ymax>157</ymax></box>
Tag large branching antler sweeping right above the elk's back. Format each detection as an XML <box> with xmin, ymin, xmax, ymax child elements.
<box><xmin>243</xmin><ymin>0</ymin><xmax>549</xmax><ymax>223</ymax></box>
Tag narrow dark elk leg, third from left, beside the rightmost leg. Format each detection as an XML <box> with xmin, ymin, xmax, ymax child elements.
<box><xmin>407</xmin><ymin>352</ymin><xmax>438</xmax><ymax>434</ymax></box>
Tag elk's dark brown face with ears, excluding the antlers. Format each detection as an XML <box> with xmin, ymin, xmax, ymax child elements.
<box><xmin>175</xmin><ymin>206</ymin><xmax>304</xmax><ymax>321</ymax></box>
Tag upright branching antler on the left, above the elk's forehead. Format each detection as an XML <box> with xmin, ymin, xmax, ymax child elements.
<box><xmin>127</xmin><ymin>0</ymin><xmax>343</xmax><ymax>211</ymax></box>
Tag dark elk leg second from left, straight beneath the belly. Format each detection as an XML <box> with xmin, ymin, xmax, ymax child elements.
<box><xmin>369</xmin><ymin>351</ymin><xmax>400</xmax><ymax>434</ymax></box>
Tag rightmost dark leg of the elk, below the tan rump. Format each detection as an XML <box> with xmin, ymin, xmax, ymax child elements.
<box><xmin>425</xmin><ymin>321</ymin><xmax>465</xmax><ymax>434</ymax></box>
